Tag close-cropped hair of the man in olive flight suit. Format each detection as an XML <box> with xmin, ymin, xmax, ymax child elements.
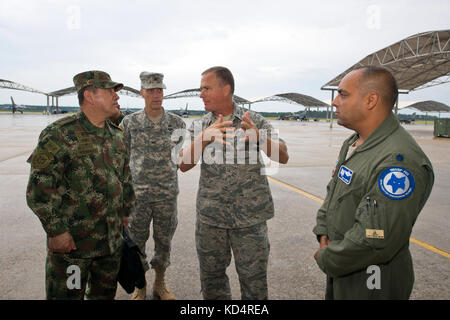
<box><xmin>354</xmin><ymin>66</ymin><xmax>398</xmax><ymax>111</ymax></box>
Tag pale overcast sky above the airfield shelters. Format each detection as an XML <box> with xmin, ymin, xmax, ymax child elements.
<box><xmin>0</xmin><ymin>0</ymin><xmax>450</xmax><ymax>111</ymax></box>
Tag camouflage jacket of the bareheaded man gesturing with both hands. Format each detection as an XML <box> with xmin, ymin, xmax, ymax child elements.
<box><xmin>189</xmin><ymin>104</ymin><xmax>283</xmax><ymax>229</ymax></box>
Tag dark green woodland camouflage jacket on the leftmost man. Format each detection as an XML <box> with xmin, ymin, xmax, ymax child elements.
<box><xmin>27</xmin><ymin>111</ymin><xmax>135</xmax><ymax>258</ymax></box>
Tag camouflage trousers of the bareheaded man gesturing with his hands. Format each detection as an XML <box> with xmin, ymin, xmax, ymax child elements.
<box><xmin>195</xmin><ymin>219</ymin><xmax>270</xmax><ymax>300</ymax></box>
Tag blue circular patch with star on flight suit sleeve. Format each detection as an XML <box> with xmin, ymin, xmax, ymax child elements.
<box><xmin>378</xmin><ymin>167</ymin><xmax>415</xmax><ymax>200</ymax></box>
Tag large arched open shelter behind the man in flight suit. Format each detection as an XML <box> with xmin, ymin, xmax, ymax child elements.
<box><xmin>321</xmin><ymin>29</ymin><xmax>450</xmax><ymax>125</ymax></box>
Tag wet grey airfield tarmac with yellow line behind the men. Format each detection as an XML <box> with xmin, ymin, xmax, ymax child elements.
<box><xmin>0</xmin><ymin>114</ymin><xmax>450</xmax><ymax>300</ymax></box>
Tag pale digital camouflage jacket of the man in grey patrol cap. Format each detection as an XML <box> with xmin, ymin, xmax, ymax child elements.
<box><xmin>121</xmin><ymin>109</ymin><xmax>186</xmax><ymax>201</ymax></box>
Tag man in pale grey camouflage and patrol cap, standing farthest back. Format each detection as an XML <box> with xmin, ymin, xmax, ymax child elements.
<box><xmin>121</xmin><ymin>71</ymin><xmax>186</xmax><ymax>300</ymax></box>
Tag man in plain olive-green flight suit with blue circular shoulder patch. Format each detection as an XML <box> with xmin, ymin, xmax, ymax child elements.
<box><xmin>313</xmin><ymin>66</ymin><xmax>434</xmax><ymax>299</ymax></box>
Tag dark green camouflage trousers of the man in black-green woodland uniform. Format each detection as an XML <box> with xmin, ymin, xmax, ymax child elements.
<box><xmin>45</xmin><ymin>248</ymin><xmax>121</xmax><ymax>300</ymax></box>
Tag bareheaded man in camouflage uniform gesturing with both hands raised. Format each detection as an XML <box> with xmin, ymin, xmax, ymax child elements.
<box><xmin>180</xmin><ymin>67</ymin><xmax>289</xmax><ymax>300</ymax></box>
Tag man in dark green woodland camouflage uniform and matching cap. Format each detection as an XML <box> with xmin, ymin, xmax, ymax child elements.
<box><xmin>27</xmin><ymin>71</ymin><xmax>135</xmax><ymax>299</ymax></box>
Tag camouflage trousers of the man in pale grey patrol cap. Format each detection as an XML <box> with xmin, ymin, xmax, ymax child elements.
<box><xmin>127</xmin><ymin>192</ymin><xmax>178</xmax><ymax>271</ymax></box>
